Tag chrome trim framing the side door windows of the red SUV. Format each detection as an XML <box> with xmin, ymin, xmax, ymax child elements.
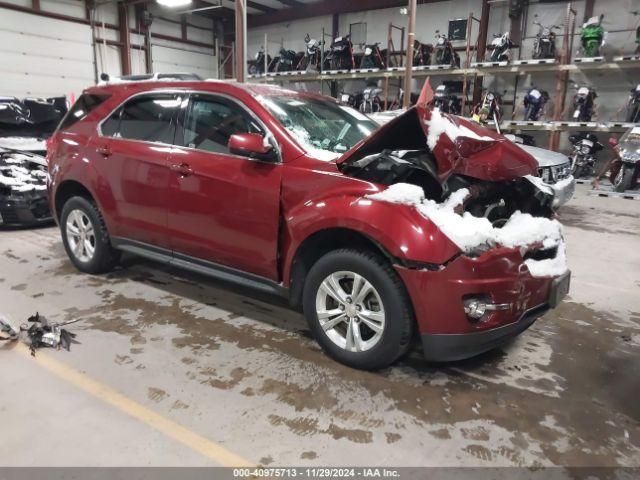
<box><xmin>97</xmin><ymin>88</ymin><xmax>283</xmax><ymax>164</ymax></box>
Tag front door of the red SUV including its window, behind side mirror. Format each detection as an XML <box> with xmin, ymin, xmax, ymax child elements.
<box><xmin>168</xmin><ymin>94</ymin><xmax>282</xmax><ymax>279</ymax></box>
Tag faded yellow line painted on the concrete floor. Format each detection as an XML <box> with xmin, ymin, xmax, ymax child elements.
<box><xmin>13</xmin><ymin>343</ymin><xmax>255</xmax><ymax>467</ymax></box>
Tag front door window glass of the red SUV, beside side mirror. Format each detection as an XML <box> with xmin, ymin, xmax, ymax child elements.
<box><xmin>180</xmin><ymin>95</ymin><xmax>264</xmax><ymax>154</ymax></box>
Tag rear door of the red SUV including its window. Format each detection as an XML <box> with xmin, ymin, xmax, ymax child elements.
<box><xmin>94</xmin><ymin>93</ymin><xmax>186</xmax><ymax>248</ymax></box>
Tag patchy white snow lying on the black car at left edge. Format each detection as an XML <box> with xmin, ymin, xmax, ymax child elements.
<box><xmin>0</xmin><ymin>150</ymin><xmax>47</xmax><ymax>192</ymax></box>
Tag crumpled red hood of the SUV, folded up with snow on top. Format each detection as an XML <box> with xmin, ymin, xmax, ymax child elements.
<box><xmin>337</xmin><ymin>106</ymin><xmax>538</xmax><ymax>181</ymax></box>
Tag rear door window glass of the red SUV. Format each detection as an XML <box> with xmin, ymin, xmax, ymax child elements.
<box><xmin>101</xmin><ymin>94</ymin><xmax>182</xmax><ymax>144</ymax></box>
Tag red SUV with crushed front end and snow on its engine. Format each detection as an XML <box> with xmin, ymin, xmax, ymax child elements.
<box><xmin>49</xmin><ymin>81</ymin><xmax>569</xmax><ymax>369</ymax></box>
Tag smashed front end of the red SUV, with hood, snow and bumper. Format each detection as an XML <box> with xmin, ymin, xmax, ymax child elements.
<box><xmin>339</xmin><ymin>108</ymin><xmax>570</xmax><ymax>361</ymax></box>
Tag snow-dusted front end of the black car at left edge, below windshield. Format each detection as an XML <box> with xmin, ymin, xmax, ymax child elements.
<box><xmin>0</xmin><ymin>148</ymin><xmax>52</xmax><ymax>225</ymax></box>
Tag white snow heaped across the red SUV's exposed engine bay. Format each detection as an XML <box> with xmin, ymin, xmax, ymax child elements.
<box><xmin>367</xmin><ymin>183</ymin><xmax>568</xmax><ymax>277</ymax></box>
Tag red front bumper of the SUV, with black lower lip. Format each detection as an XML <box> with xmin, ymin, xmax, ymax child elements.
<box><xmin>395</xmin><ymin>248</ymin><xmax>569</xmax><ymax>361</ymax></box>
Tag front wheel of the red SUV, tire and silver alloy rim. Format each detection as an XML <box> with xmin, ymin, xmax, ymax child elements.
<box><xmin>303</xmin><ymin>249</ymin><xmax>414</xmax><ymax>370</ymax></box>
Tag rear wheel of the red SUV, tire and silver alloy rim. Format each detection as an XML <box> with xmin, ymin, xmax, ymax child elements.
<box><xmin>60</xmin><ymin>197</ymin><xmax>120</xmax><ymax>274</ymax></box>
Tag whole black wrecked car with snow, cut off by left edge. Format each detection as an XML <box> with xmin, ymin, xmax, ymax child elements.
<box><xmin>0</xmin><ymin>97</ymin><xmax>67</xmax><ymax>226</ymax></box>
